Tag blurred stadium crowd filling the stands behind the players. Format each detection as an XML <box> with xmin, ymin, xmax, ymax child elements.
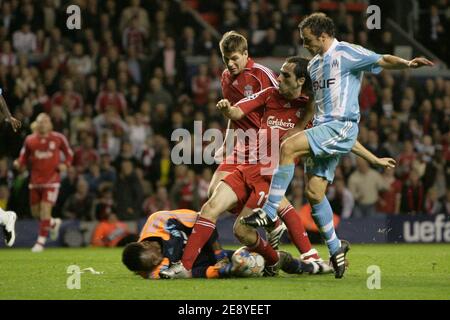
<box><xmin>0</xmin><ymin>0</ymin><xmax>450</xmax><ymax>228</ymax></box>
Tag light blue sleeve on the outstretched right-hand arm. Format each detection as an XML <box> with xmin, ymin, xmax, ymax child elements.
<box><xmin>342</xmin><ymin>44</ymin><xmax>383</xmax><ymax>74</ymax></box>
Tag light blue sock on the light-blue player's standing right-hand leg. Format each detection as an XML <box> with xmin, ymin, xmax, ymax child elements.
<box><xmin>312</xmin><ymin>197</ymin><xmax>341</xmax><ymax>255</ymax></box>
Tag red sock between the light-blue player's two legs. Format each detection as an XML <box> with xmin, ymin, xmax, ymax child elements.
<box><xmin>279</xmin><ymin>205</ymin><xmax>311</xmax><ymax>254</ymax></box>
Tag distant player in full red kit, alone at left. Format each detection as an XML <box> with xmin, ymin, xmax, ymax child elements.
<box><xmin>14</xmin><ymin>113</ymin><xmax>73</xmax><ymax>252</ymax></box>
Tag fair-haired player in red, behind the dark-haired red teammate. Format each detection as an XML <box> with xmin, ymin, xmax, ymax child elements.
<box><xmin>213</xmin><ymin>31</ymin><xmax>321</xmax><ymax>261</ymax></box>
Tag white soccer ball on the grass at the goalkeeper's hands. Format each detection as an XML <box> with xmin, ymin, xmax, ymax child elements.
<box><xmin>231</xmin><ymin>247</ymin><xmax>264</xmax><ymax>277</ymax></box>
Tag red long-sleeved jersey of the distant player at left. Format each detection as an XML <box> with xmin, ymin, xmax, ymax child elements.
<box><xmin>19</xmin><ymin>131</ymin><xmax>73</xmax><ymax>186</ymax></box>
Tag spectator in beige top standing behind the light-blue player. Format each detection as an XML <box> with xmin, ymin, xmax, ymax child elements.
<box><xmin>348</xmin><ymin>157</ymin><xmax>389</xmax><ymax>218</ymax></box>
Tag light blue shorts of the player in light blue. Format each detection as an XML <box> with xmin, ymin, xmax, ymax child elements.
<box><xmin>305</xmin><ymin>120</ymin><xmax>358</xmax><ymax>183</ymax></box>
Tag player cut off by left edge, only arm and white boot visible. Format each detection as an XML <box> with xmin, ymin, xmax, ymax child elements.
<box><xmin>0</xmin><ymin>88</ymin><xmax>22</xmax><ymax>247</ymax></box>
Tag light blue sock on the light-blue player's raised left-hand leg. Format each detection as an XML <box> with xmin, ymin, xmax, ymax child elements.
<box><xmin>263</xmin><ymin>164</ymin><xmax>295</xmax><ymax>221</ymax></box>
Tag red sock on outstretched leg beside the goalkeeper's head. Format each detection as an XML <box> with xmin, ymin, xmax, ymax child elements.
<box><xmin>181</xmin><ymin>217</ymin><xmax>216</xmax><ymax>270</ymax></box>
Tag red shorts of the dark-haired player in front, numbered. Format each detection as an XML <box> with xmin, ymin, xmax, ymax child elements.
<box><xmin>223</xmin><ymin>164</ymin><xmax>272</xmax><ymax>214</ymax></box>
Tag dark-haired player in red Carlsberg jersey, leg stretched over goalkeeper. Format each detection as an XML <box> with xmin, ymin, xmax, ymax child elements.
<box><xmin>160</xmin><ymin>57</ymin><xmax>322</xmax><ymax>278</ymax></box>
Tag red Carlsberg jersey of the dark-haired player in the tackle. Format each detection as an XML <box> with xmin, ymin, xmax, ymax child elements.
<box><xmin>236</xmin><ymin>87</ymin><xmax>308</xmax><ymax>162</ymax></box>
